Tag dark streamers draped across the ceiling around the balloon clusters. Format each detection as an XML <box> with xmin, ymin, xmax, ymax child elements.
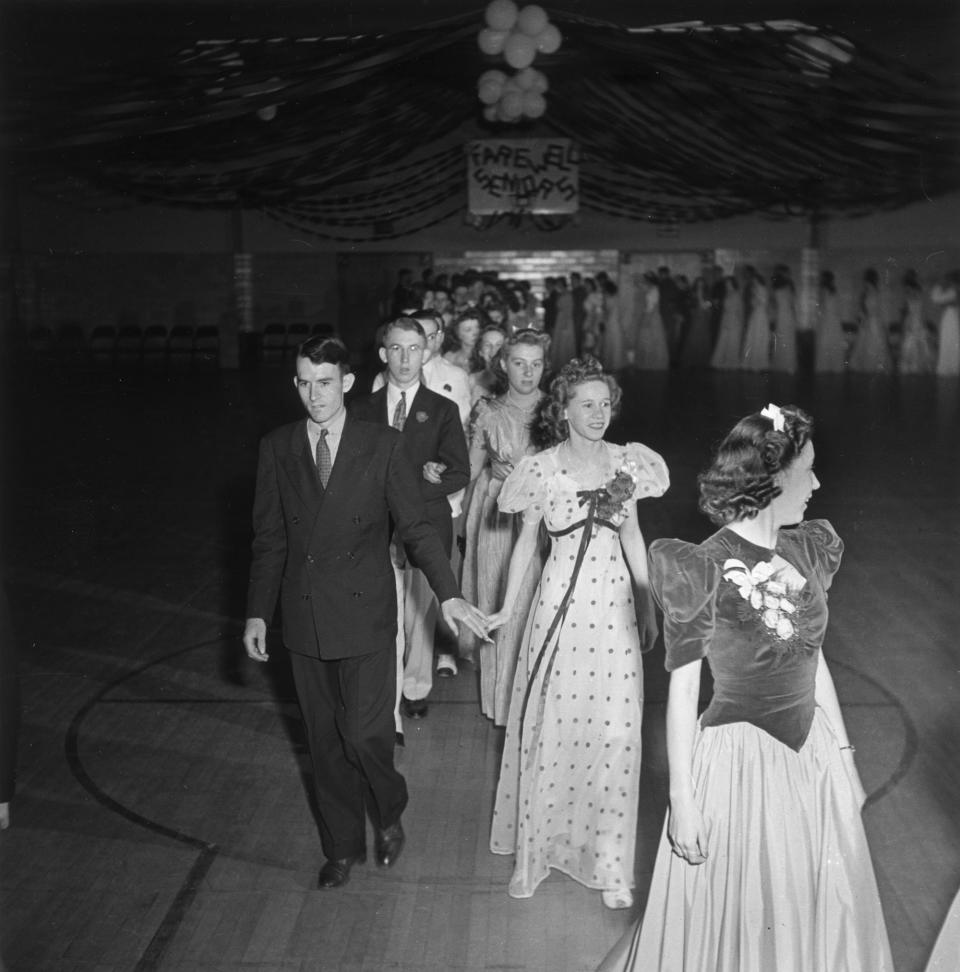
<box><xmin>2</xmin><ymin>11</ymin><xmax>960</xmax><ymax>241</ymax></box>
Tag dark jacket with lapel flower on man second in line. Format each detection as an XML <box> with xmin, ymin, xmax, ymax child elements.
<box><xmin>350</xmin><ymin>383</ymin><xmax>470</xmax><ymax>566</ymax></box>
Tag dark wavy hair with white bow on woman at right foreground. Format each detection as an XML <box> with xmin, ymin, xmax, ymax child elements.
<box><xmin>697</xmin><ymin>405</ymin><xmax>813</xmax><ymax>526</ymax></box>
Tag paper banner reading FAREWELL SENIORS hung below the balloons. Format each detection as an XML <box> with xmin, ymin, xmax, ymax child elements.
<box><xmin>467</xmin><ymin>138</ymin><xmax>580</xmax><ymax>216</ymax></box>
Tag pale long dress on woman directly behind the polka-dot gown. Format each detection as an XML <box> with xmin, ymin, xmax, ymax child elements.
<box><xmin>461</xmin><ymin>396</ymin><xmax>541</xmax><ymax>726</ymax></box>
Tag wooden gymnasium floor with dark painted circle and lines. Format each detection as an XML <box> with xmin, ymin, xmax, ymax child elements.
<box><xmin>0</xmin><ymin>370</ymin><xmax>960</xmax><ymax>972</ymax></box>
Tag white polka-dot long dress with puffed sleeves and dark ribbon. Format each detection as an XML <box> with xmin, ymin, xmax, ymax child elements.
<box><xmin>490</xmin><ymin>443</ymin><xmax>669</xmax><ymax>898</ymax></box>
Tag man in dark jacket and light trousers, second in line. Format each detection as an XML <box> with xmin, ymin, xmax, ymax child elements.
<box><xmin>351</xmin><ymin>317</ymin><xmax>470</xmax><ymax>719</ymax></box>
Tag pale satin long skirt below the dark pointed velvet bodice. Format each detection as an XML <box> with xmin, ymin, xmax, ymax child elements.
<box><xmin>600</xmin><ymin>709</ymin><xmax>893</xmax><ymax>972</ymax></box>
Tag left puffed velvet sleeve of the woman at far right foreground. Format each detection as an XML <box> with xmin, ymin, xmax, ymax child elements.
<box><xmin>649</xmin><ymin>540</ymin><xmax>720</xmax><ymax>672</ymax></box>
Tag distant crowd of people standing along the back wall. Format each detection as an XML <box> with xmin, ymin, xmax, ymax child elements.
<box><xmin>390</xmin><ymin>263</ymin><xmax>960</xmax><ymax>387</ymax></box>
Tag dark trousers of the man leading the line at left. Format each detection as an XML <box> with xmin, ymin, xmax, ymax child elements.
<box><xmin>290</xmin><ymin>651</ymin><xmax>407</xmax><ymax>858</ymax></box>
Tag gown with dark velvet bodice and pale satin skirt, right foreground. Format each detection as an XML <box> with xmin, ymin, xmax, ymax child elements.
<box><xmin>601</xmin><ymin>520</ymin><xmax>893</xmax><ymax>972</ymax></box>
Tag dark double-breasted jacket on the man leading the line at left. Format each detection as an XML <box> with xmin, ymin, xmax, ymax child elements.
<box><xmin>247</xmin><ymin>412</ymin><xmax>462</xmax><ymax>660</ymax></box>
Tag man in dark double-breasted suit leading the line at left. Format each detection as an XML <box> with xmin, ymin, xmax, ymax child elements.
<box><xmin>243</xmin><ymin>337</ymin><xmax>486</xmax><ymax>888</ymax></box>
